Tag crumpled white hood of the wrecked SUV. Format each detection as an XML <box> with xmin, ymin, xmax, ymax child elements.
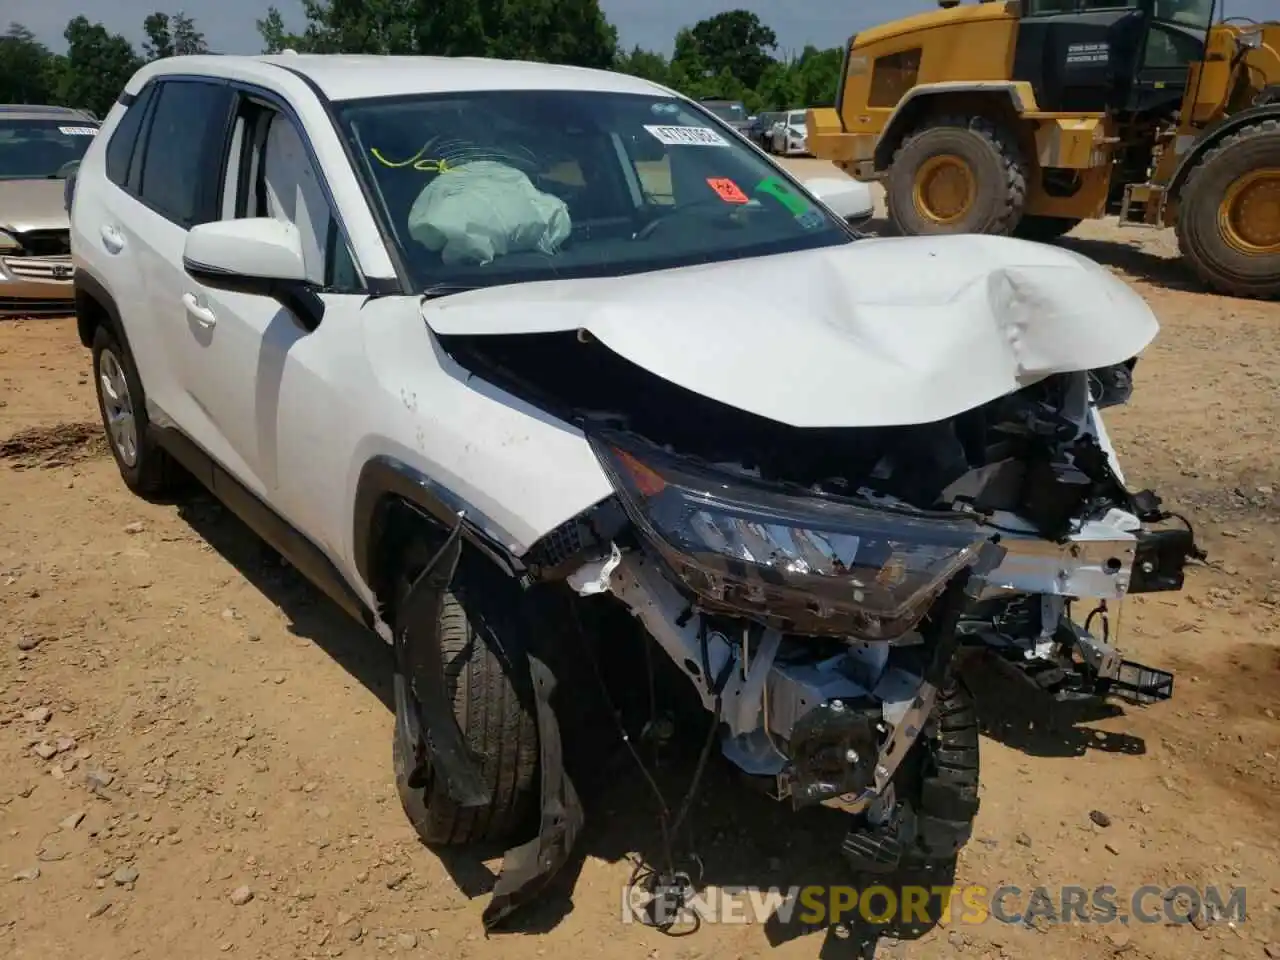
<box><xmin>422</xmin><ymin>236</ymin><xmax>1158</xmax><ymax>428</ymax></box>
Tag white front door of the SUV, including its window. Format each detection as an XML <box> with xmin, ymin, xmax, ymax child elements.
<box><xmin>182</xmin><ymin>93</ymin><xmax>365</xmax><ymax>557</ymax></box>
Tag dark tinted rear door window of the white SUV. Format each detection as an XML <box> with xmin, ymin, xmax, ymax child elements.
<box><xmin>140</xmin><ymin>81</ymin><xmax>232</xmax><ymax>229</ymax></box>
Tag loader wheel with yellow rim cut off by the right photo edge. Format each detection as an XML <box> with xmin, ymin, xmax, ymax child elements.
<box><xmin>1178</xmin><ymin>119</ymin><xmax>1280</xmax><ymax>300</ymax></box>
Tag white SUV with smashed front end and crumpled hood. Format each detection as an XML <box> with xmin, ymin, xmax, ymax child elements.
<box><xmin>72</xmin><ymin>55</ymin><xmax>1198</xmax><ymax>922</ymax></box>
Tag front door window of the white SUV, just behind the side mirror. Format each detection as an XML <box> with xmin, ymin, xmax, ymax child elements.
<box><xmin>221</xmin><ymin>99</ymin><xmax>364</xmax><ymax>293</ymax></box>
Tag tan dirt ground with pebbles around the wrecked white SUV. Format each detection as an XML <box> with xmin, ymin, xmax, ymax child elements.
<box><xmin>0</xmin><ymin>161</ymin><xmax>1280</xmax><ymax>960</ymax></box>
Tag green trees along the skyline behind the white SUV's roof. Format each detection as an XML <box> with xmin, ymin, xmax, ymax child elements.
<box><xmin>0</xmin><ymin>0</ymin><xmax>842</xmax><ymax>116</ymax></box>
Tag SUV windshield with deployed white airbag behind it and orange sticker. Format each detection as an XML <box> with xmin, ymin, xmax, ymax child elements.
<box><xmin>338</xmin><ymin>91</ymin><xmax>854</xmax><ymax>291</ymax></box>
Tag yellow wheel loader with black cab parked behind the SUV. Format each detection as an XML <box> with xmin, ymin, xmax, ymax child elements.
<box><xmin>808</xmin><ymin>0</ymin><xmax>1280</xmax><ymax>297</ymax></box>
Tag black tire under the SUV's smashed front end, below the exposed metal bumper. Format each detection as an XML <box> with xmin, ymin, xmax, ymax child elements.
<box><xmin>905</xmin><ymin>678</ymin><xmax>979</xmax><ymax>864</ymax></box>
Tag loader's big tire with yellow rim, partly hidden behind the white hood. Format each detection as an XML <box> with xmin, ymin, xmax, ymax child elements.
<box><xmin>886</xmin><ymin>116</ymin><xmax>1027</xmax><ymax>237</ymax></box>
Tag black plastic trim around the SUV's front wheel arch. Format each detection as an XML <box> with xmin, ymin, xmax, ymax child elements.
<box><xmin>352</xmin><ymin>454</ymin><xmax>526</xmax><ymax>609</ymax></box>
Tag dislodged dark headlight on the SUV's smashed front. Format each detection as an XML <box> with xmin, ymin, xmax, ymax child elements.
<box><xmin>591</xmin><ymin>433</ymin><xmax>987</xmax><ymax>640</ymax></box>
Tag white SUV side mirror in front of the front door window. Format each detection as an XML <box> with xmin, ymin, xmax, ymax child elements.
<box><xmin>182</xmin><ymin>216</ymin><xmax>324</xmax><ymax>330</ymax></box>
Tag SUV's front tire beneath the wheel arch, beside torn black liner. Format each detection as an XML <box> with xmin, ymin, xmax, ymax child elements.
<box><xmin>393</xmin><ymin>544</ymin><xmax>539</xmax><ymax>846</ymax></box>
